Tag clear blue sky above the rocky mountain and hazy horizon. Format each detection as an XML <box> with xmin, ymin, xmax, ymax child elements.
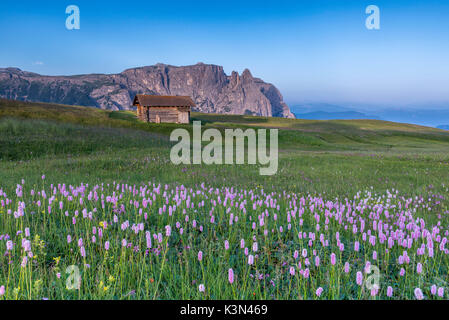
<box><xmin>0</xmin><ymin>0</ymin><xmax>449</xmax><ymax>106</ymax></box>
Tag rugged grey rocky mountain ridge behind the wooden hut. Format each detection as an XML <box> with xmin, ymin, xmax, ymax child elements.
<box><xmin>0</xmin><ymin>63</ymin><xmax>294</xmax><ymax>118</ymax></box>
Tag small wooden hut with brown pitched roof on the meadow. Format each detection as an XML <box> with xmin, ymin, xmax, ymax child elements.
<box><xmin>133</xmin><ymin>94</ymin><xmax>195</xmax><ymax>123</ymax></box>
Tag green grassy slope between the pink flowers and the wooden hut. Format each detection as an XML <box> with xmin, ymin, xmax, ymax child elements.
<box><xmin>0</xmin><ymin>100</ymin><xmax>449</xmax><ymax>196</ymax></box>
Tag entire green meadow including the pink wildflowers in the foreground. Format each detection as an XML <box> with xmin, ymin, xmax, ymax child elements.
<box><xmin>0</xmin><ymin>100</ymin><xmax>449</xmax><ymax>300</ymax></box>
